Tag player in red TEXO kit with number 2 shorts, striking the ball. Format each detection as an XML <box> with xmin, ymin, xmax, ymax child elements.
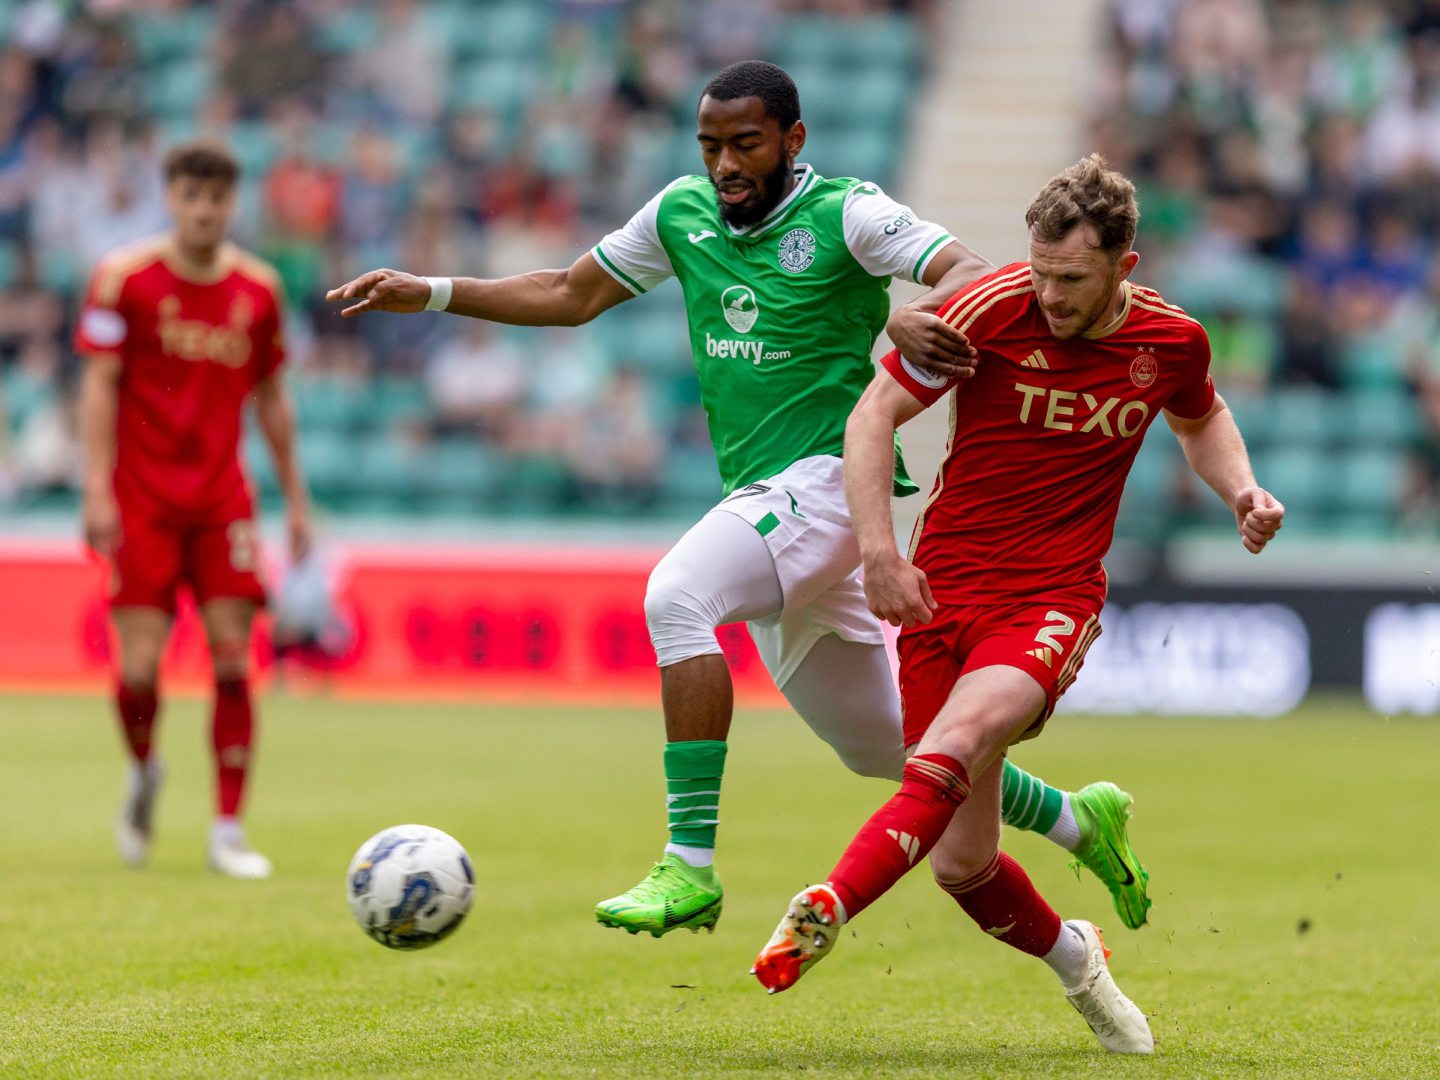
<box><xmin>755</xmin><ymin>156</ymin><xmax>1284</xmax><ymax>1054</ymax></box>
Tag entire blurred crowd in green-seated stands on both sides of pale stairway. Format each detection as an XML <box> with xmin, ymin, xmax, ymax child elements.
<box><xmin>0</xmin><ymin>0</ymin><xmax>1440</xmax><ymax>534</ymax></box>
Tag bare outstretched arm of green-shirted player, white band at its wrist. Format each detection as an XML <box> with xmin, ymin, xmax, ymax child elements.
<box><xmin>334</xmin><ymin>252</ymin><xmax>634</xmax><ymax>327</ymax></box>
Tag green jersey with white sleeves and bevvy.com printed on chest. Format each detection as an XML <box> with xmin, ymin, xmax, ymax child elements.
<box><xmin>593</xmin><ymin>166</ymin><xmax>953</xmax><ymax>494</ymax></box>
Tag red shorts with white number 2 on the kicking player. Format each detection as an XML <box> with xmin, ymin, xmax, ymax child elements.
<box><xmin>899</xmin><ymin>599</ymin><xmax>1100</xmax><ymax>746</ymax></box>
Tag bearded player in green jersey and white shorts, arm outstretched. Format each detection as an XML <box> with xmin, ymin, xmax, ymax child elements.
<box><xmin>328</xmin><ymin>60</ymin><xmax>1149</xmax><ymax>937</ymax></box>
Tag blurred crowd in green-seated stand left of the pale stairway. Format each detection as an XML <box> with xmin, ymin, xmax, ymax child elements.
<box><xmin>0</xmin><ymin>0</ymin><xmax>919</xmax><ymax>524</ymax></box>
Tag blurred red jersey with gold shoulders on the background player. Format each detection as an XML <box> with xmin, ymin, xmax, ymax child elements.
<box><xmin>75</xmin><ymin>238</ymin><xmax>284</xmax><ymax>514</ymax></box>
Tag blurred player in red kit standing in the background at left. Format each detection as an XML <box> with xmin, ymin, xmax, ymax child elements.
<box><xmin>75</xmin><ymin>143</ymin><xmax>310</xmax><ymax>878</ymax></box>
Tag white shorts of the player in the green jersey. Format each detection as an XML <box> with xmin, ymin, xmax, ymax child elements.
<box><xmin>710</xmin><ymin>454</ymin><xmax>886</xmax><ymax>690</ymax></box>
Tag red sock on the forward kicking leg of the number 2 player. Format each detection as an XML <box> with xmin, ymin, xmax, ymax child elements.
<box><xmin>829</xmin><ymin>753</ymin><xmax>971</xmax><ymax>919</ymax></box>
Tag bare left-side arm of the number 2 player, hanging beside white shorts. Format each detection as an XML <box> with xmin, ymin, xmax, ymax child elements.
<box><xmin>845</xmin><ymin>372</ymin><xmax>935</xmax><ymax>626</ymax></box>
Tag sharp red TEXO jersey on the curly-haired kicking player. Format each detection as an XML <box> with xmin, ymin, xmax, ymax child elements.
<box><xmin>883</xmin><ymin>262</ymin><xmax>1215</xmax><ymax>605</ymax></box>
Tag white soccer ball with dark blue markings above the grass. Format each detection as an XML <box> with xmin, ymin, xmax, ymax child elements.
<box><xmin>346</xmin><ymin>825</ymin><xmax>475</xmax><ymax>949</ymax></box>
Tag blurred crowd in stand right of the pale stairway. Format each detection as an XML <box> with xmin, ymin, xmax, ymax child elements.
<box><xmin>1093</xmin><ymin>0</ymin><xmax>1440</xmax><ymax>533</ymax></box>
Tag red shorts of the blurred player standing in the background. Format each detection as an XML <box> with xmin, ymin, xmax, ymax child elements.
<box><xmin>109</xmin><ymin>500</ymin><xmax>265</xmax><ymax>613</ymax></box>
